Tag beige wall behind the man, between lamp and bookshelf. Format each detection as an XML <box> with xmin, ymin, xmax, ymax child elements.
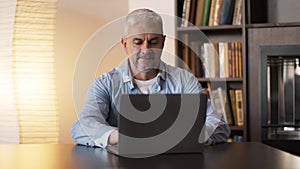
<box><xmin>55</xmin><ymin>0</ymin><xmax>175</xmax><ymax>143</ymax></box>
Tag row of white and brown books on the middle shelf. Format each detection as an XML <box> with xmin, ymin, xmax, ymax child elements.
<box><xmin>201</xmin><ymin>42</ymin><xmax>243</xmax><ymax>78</ymax></box>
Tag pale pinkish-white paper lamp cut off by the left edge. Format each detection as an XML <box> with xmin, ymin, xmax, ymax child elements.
<box><xmin>0</xmin><ymin>0</ymin><xmax>19</xmax><ymax>143</ymax></box>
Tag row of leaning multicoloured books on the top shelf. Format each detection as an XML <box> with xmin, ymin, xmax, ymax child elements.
<box><xmin>179</xmin><ymin>0</ymin><xmax>243</xmax><ymax>27</ymax></box>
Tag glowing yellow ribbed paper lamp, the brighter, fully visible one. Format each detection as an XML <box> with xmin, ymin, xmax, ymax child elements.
<box><xmin>13</xmin><ymin>0</ymin><xmax>59</xmax><ymax>143</ymax></box>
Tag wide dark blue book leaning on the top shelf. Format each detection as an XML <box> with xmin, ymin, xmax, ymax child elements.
<box><xmin>220</xmin><ymin>0</ymin><xmax>235</xmax><ymax>25</ymax></box>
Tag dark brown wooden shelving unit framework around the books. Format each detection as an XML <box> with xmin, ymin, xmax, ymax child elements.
<box><xmin>175</xmin><ymin>0</ymin><xmax>300</xmax><ymax>154</ymax></box>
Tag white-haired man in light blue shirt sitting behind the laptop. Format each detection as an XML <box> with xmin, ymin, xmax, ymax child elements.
<box><xmin>71</xmin><ymin>9</ymin><xmax>230</xmax><ymax>147</ymax></box>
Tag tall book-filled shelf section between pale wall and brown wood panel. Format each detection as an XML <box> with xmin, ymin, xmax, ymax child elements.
<box><xmin>176</xmin><ymin>0</ymin><xmax>248</xmax><ymax>141</ymax></box>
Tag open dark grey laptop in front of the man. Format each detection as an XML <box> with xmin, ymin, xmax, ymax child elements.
<box><xmin>107</xmin><ymin>94</ymin><xmax>207</xmax><ymax>157</ymax></box>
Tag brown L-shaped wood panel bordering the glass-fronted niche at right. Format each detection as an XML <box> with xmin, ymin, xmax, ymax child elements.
<box><xmin>247</xmin><ymin>26</ymin><xmax>300</xmax><ymax>141</ymax></box>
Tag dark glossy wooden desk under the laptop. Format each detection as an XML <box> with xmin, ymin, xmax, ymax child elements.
<box><xmin>0</xmin><ymin>142</ymin><xmax>300</xmax><ymax>169</ymax></box>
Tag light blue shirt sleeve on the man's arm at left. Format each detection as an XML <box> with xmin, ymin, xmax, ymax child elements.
<box><xmin>71</xmin><ymin>78</ymin><xmax>116</xmax><ymax>147</ymax></box>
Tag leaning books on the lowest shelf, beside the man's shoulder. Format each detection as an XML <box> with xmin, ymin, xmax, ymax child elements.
<box><xmin>209</xmin><ymin>87</ymin><xmax>244</xmax><ymax>126</ymax></box>
